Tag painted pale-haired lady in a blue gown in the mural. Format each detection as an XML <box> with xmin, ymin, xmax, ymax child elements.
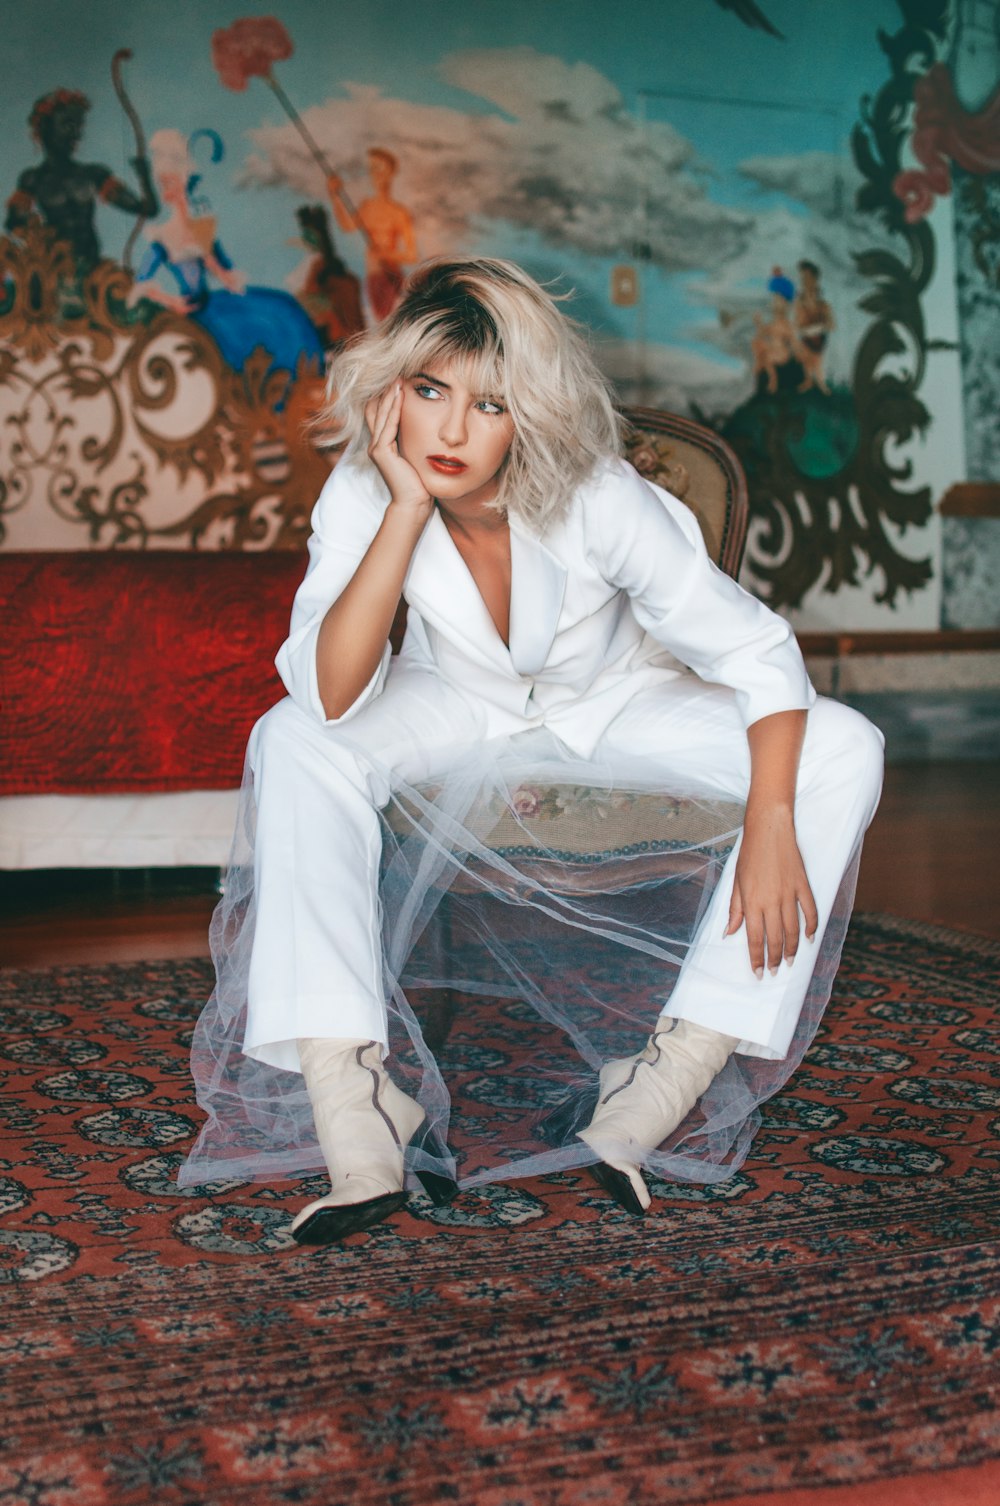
<box><xmin>130</xmin><ymin>130</ymin><xmax>322</xmax><ymax>385</ymax></box>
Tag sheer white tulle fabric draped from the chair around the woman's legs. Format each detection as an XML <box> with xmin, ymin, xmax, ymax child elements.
<box><xmin>179</xmin><ymin>732</ymin><xmax>857</xmax><ymax>1187</ymax></box>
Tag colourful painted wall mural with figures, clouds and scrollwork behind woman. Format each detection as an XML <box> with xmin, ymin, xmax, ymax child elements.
<box><xmin>0</xmin><ymin>0</ymin><xmax>1000</xmax><ymax>626</ymax></box>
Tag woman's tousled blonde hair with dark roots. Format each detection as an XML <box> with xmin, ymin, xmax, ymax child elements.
<box><xmin>319</xmin><ymin>258</ymin><xmax>622</xmax><ymax>533</ymax></box>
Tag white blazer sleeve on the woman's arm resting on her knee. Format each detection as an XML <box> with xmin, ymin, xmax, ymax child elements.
<box><xmin>584</xmin><ymin>461</ymin><xmax>816</xmax><ymax>726</ymax></box>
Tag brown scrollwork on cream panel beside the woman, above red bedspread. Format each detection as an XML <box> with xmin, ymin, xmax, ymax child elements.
<box><xmin>0</xmin><ymin>220</ymin><xmax>330</xmax><ymax>548</ymax></box>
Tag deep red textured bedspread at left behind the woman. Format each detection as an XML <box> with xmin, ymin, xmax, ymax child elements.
<box><xmin>0</xmin><ymin>551</ymin><xmax>306</xmax><ymax>795</ymax></box>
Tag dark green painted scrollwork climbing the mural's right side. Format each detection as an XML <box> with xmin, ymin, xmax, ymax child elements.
<box><xmin>715</xmin><ymin>0</ymin><xmax>947</xmax><ymax>607</ymax></box>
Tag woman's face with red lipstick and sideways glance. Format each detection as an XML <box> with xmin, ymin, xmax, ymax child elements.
<box><xmin>398</xmin><ymin>360</ymin><xmax>514</xmax><ymax>508</ymax></box>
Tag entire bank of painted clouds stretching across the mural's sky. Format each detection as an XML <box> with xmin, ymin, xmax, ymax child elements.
<box><xmin>241</xmin><ymin>47</ymin><xmax>903</xmax><ymax>410</ymax></box>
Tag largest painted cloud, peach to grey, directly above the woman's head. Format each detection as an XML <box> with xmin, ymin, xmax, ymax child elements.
<box><xmin>242</xmin><ymin>47</ymin><xmax>753</xmax><ymax>271</ymax></box>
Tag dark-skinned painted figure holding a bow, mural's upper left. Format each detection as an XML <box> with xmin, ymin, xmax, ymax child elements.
<box><xmin>5</xmin><ymin>89</ymin><xmax>158</xmax><ymax>274</ymax></box>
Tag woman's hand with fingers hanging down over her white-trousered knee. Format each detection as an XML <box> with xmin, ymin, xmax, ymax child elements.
<box><xmin>726</xmin><ymin>806</ymin><xmax>819</xmax><ymax>977</ymax></box>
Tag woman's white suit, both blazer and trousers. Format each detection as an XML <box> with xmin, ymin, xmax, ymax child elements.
<box><xmin>244</xmin><ymin>456</ymin><xmax>881</xmax><ymax>1069</ymax></box>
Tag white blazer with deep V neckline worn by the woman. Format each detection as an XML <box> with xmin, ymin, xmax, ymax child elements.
<box><xmin>276</xmin><ymin>455</ymin><xmax>816</xmax><ymax>758</ymax></box>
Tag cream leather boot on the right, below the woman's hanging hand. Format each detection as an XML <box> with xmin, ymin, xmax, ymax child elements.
<box><xmin>578</xmin><ymin>1018</ymin><xmax>738</xmax><ymax>1214</ymax></box>
